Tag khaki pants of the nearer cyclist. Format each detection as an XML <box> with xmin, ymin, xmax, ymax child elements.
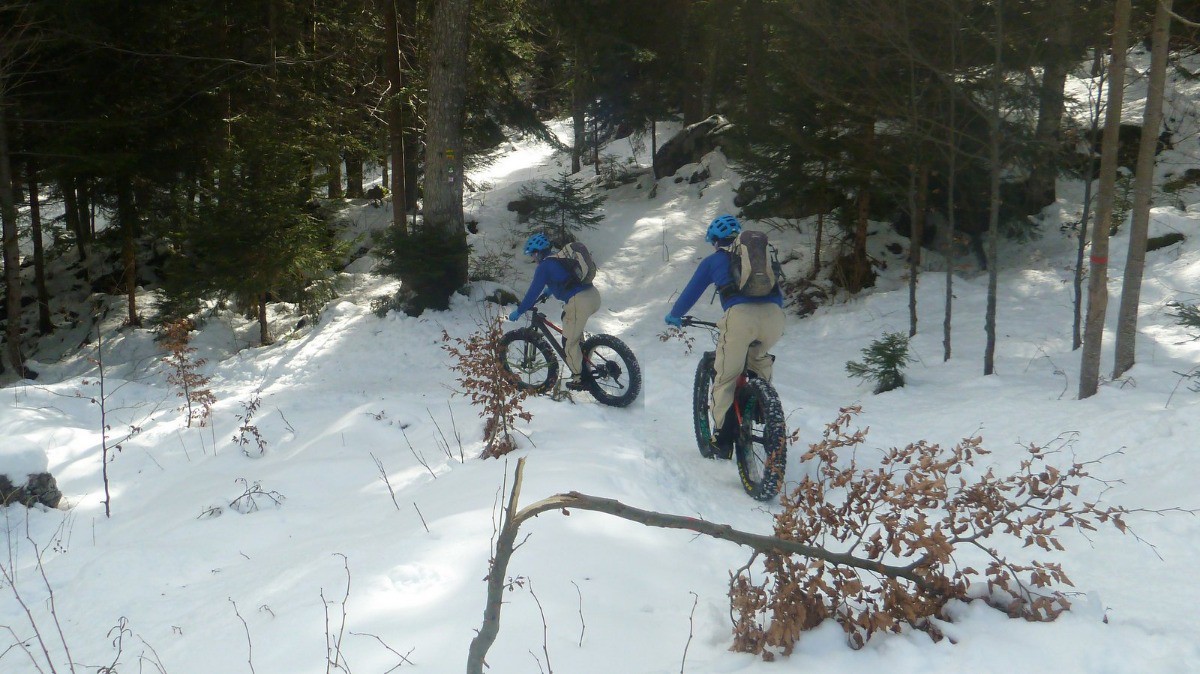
<box><xmin>710</xmin><ymin>302</ymin><xmax>784</xmax><ymax>431</ymax></box>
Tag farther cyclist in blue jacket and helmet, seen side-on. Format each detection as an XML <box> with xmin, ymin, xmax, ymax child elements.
<box><xmin>509</xmin><ymin>234</ymin><xmax>600</xmax><ymax>391</ymax></box>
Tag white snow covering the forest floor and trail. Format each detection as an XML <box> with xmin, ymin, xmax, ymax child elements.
<box><xmin>0</xmin><ymin>70</ymin><xmax>1200</xmax><ymax>674</ymax></box>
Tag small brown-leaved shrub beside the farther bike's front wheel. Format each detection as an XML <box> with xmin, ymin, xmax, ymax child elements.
<box><xmin>442</xmin><ymin>317</ymin><xmax>533</xmax><ymax>458</ymax></box>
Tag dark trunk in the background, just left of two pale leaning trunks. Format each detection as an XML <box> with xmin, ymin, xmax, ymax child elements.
<box><xmin>1025</xmin><ymin>0</ymin><xmax>1073</xmax><ymax>209</ymax></box>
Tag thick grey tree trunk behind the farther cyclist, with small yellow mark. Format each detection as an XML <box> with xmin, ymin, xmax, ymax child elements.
<box><xmin>414</xmin><ymin>0</ymin><xmax>470</xmax><ymax>309</ymax></box>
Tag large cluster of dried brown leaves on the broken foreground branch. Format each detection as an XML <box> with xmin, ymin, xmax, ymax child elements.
<box><xmin>730</xmin><ymin>407</ymin><xmax>1129</xmax><ymax>660</ymax></box>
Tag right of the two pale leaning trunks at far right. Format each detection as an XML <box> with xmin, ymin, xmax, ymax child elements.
<box><xmin>1112</xmin><ymin>0</ymin><xmax>1174</xmax><ymax>379</ymax></box>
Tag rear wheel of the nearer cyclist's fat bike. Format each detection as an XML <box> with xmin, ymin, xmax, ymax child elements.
<box><xmin>731</xmin><ymin>377</ymin><xmax>787</xmax><ymax>501</ymax></box>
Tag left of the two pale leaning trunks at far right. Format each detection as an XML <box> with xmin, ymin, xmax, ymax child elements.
<box><xmin>1079</xmin><ymin>0</ymin><xmax>1130</xmax><ymax>399</ymax></box>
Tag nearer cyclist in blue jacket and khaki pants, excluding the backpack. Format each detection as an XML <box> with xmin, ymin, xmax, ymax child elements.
<box><xmin>666</xmin><ymin>215</ymin><xmax>784</xmax><ymax>458</ymax></box>
